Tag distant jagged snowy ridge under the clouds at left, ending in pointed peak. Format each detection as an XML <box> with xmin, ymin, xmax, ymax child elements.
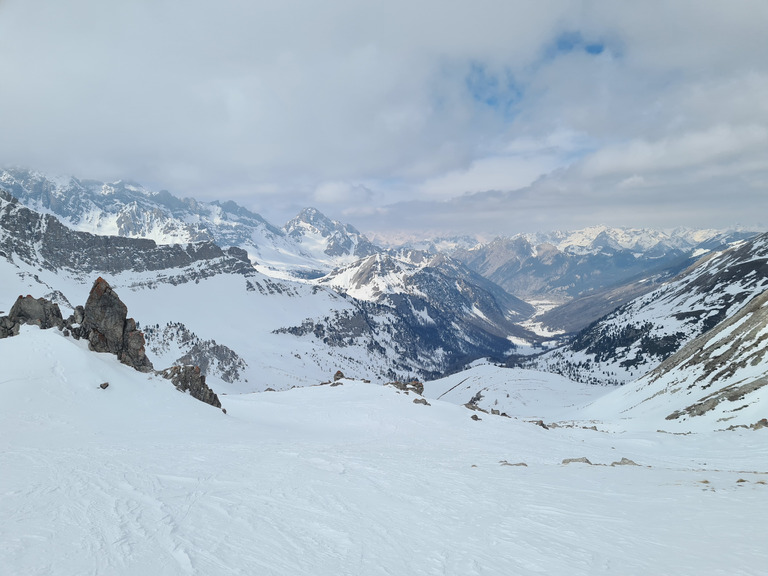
<box><xmin>0</xmin><ymin>168</ymin><xmax>375</xmax><ymax>277</ymax></box>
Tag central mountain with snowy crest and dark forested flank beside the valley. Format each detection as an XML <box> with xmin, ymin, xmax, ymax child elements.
<box><xmin>276</xmin><ymin>252</ymin><xmax>539</xmax><ymax>376</ymax></box>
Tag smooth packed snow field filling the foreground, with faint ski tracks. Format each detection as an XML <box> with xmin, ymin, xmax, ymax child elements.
<box><xmin>0</xmin><ymin>327</ymin><xmax>768</xmax><ymax>576</ymax></box>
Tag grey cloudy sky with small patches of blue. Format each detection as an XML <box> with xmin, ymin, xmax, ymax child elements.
<box><xmin>0</xmin><ymin>0</ymin><xmax>768</xmax><ymax>235</ymax></box>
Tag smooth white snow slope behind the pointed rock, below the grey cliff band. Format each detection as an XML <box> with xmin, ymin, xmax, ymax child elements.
<box><xmin>0</xmin><ymin>249</ymin><xmax>436</xmax><ymax>392</ymax></box>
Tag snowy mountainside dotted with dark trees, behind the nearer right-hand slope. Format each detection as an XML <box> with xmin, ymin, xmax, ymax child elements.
<box><xmin>528</xmin><ymin>234</ymin><xmax>768</xmax><ymax>384</ymax></box>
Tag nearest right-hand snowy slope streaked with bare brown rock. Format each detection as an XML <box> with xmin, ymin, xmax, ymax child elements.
<box><xmin>584</xmin><ymin>292</ymin><xmax>768</xmax><ymax>431</ymax></box>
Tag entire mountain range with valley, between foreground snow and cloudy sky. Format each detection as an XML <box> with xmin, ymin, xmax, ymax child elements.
<box><xmin>0</xmin><ymin>169</ymin><xmax>768</xmax><ymax>428</ymax></box>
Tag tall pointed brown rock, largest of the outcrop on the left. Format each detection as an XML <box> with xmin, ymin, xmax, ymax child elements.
<box><xmin>81</xmin><ymin>277</ymin><xmax>153</xmax><ymax>372</ymax></box>
